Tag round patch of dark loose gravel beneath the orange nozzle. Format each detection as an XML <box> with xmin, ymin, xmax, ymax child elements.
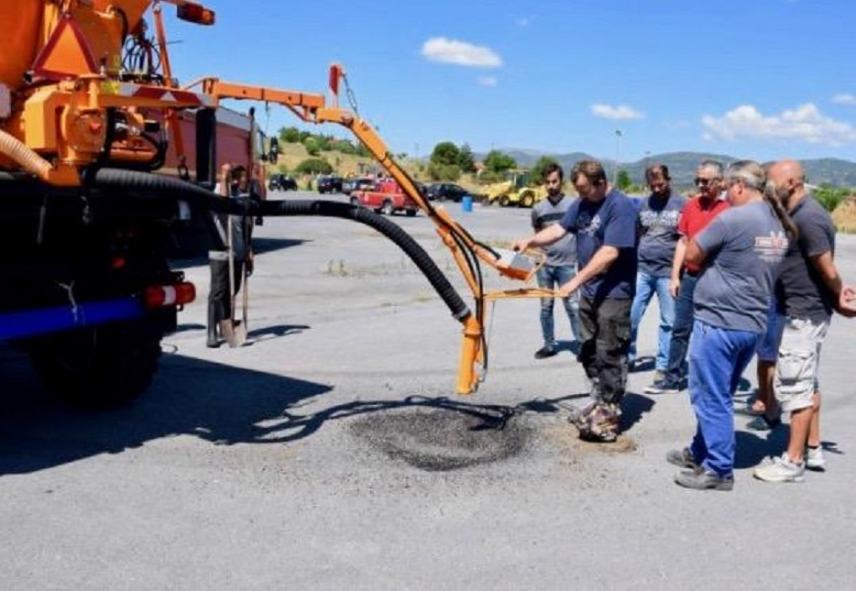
<box><xmin>351</xmin><ymin>408</ymin><xmax>530</xmax><ymax>472</ymax></box>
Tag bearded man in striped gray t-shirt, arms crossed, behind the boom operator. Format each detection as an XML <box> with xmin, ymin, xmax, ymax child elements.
<box><xmin>532</xmin><ymin>164</ymin><xmax>580</xmax><ymax>359</ymax></box>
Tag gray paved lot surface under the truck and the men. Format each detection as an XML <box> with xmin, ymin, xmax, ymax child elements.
<box><xmin>0</xmin><ymin>193</ymin><xmax>856</xmax><ymax>590</ymax></box>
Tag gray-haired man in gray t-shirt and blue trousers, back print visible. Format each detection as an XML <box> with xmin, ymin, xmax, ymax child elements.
<box><xmin>666</xmin><ymin>160</ymin><xmax>793</xmax><ymax>490</ymax></box>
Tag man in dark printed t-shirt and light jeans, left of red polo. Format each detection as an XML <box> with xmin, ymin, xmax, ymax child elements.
<box><xmin>630</xmin><ymin>164</ymin><xmax>687</xmax><ymax>383</ymax></box>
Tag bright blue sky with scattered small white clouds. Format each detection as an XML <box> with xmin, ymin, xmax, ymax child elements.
<box><xmin>159</xmin><ymin>0</ymin><xmax>856</xmax><ymax>161</ymax></box>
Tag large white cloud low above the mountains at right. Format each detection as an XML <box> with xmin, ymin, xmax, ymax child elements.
<box><xmin>701</xmin><ymin>103</ymin><xmax>856</xmax><ymax>146</ymax></box>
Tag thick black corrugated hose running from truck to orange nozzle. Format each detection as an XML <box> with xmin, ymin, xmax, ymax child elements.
<box><xmin>84</xmin><ymin>168</ymin><xmax>470</xmax><ymax>322</ymax></box>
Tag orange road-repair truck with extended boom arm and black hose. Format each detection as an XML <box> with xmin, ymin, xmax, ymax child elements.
<box><xmin>0</xmin><ymin>0</ymin><xmax>554</xmax><ymax>404</ymax></box>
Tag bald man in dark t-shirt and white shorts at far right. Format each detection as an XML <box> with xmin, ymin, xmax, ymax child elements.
<box><xmin>755</xmin><ymin>160</ymin><xmax>856</xmax><ymax>482</ymax></box>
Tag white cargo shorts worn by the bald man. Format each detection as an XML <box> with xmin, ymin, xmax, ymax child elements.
<box><xmin>773</xmin><ymin>318</ymin><xmax>829</xmax><ymax>412</ymax></box>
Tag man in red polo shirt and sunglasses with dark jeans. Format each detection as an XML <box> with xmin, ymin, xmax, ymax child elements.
<box><xmin>645</xmin><ymin>160</ymin><xmax>729</xmax><ymax>394</ymax></box>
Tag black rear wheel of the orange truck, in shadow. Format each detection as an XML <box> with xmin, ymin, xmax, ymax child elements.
<box><xmin>30</xmin><ymin>320</ymin><xmax>161</xmax><ymax>408</ymax></box>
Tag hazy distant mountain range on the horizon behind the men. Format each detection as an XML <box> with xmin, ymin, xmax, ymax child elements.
<box><xmin>475</xmin><ymin>148</ymin><xmax>856</xmax><ymax>187</ymax></box>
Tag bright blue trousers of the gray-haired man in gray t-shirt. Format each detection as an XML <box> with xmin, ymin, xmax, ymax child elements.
<box><xmin>689</xmin><ymin>320</ymin><xmax>760</xmax><ymax>476</ymax></box>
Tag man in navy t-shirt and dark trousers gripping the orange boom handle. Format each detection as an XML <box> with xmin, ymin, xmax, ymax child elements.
<box><xmin>514</xmin><ymin>160</ymin><xmax>637</xmax><ymax>441</ymax></box>
